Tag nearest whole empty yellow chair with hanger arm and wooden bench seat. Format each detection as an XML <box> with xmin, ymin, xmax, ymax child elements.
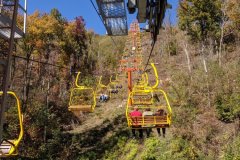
<box><xmin>68</xmin><ymin>72</ymin><xmax>96</xmax><ymax>115</ymax></box>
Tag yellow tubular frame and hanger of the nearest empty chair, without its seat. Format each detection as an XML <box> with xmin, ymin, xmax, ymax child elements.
<box><xmin>69</xmin><ymin>72</ymin><xmax>97</xmax><ymax>112</ymax></box>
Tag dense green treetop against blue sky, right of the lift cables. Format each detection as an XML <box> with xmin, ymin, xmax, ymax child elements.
<box><xmin>178</xmin><ymin>0</ymin><xmax>222</xmax><ymax>41</ymax></box>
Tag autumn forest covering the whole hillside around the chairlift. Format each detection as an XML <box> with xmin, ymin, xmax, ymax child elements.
<box><xmin>0</xmin><ymin>0</ymin><xmax>240</xmax><ymax>160</ymax></box>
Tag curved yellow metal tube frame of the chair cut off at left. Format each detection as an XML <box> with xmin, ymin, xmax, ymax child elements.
<box><xmin>0</xmin><ymin>91</ymin><xmax>24</xmax><ymax>158</ymax></box>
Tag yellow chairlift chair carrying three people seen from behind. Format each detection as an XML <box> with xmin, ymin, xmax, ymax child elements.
<box><xmin>126</xmin><ymin>63</ymin><xmax>172</xmax><ymax>129</ymax></box>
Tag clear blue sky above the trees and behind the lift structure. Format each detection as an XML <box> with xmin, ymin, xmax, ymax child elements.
<box><xmin>28</xmin><ymin>0</ymin><xmax>178</xmax><ymax>34</ymax></box>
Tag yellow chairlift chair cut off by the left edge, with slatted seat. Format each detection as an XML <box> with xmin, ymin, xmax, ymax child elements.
<box><xmin>0</xmin><ymin>91</ymin><xmax>23</xmax><ymax>158</ymax></box>
